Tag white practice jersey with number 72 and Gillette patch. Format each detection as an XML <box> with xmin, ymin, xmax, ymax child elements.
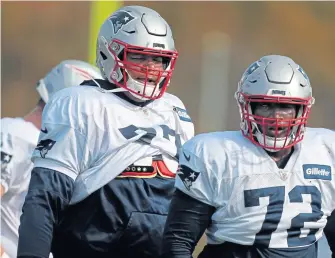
<box><xmin>176</xmin><ymin>128</ymin><xmax>335</xmax><ymax>248</ymax></box>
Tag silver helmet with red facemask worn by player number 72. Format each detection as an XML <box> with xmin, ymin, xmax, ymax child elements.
<box><xmin>235</xmin><ymin>55</ymin><xmax>314</xmax><ymax>152</ymax></box>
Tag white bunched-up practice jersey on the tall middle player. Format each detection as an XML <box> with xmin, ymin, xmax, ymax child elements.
<box><xmin>32</xmin><ymin>86</ymin><xmax>194</xmax><ymax>204</ymax></box>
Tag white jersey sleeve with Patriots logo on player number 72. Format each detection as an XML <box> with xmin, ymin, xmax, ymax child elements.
<box><xmin>175</xmin><ymin>137</ymin><xmax>218</xmax><ymax>207</ymax></box>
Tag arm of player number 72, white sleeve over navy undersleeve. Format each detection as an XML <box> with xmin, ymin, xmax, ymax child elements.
<box><xmin>162</xmin><ymin>138</ymin><xmax>218</xmax><ymax>258</ymax></box>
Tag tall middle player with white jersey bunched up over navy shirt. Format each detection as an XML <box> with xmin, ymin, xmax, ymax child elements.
<box><xmin>18</xmin><ymin>6</ymin><xmax>194</xmax><ymax>258</ymax></box>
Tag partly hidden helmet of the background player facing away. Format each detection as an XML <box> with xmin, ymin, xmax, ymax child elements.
<box><xmin>36</xmin><ymin>60</ymin><xmax>103</xmax><ymax>103</ymax></box>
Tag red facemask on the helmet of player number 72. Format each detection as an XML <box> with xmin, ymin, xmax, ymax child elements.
<box><xmin>236</xmin><ymin>92</ymin><xmax>314</xmax><ymax>152</ymax></box>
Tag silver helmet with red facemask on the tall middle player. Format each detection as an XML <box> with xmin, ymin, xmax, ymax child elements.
<box><xmin>96</xmin><ymin>6</ymin><xmax>178</xmax><ymax>101</ymax></box>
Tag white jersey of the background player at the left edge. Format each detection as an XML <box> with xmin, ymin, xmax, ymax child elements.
<box><xmin>1</xmin><ymin>118</ymin><xmax>39</xmax><ymax>244</ymax></box>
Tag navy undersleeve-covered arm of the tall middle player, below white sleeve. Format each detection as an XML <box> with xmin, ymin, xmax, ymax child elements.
<box><xmin>18</xmin><ymin>167</ymin><xmax>74</xmax><ymax>258</ymax></box>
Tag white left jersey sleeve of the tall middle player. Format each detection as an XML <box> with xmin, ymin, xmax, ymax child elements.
<box><xmin>32</xmin><ymin>90</ymin><xmax>94</xmax><ymax>179</ymax></box>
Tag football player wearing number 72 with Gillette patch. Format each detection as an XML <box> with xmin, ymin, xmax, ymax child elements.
<box><xmin>162</xmin><ymin>55</ymin><xmax>335</xmax><ymax>258</ymax></box>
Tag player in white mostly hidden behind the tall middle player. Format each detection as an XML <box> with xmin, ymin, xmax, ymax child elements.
<box><xmin>0</xmin><ymin>60</ymin><xmax>102</xmax><ymax>258</ymax></box>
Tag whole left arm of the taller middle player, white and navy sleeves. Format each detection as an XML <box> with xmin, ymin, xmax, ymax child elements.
<box><xmin>17</xmin><ymin>94</ymin><xmax>86</xmax><ymax>258</ymax></box>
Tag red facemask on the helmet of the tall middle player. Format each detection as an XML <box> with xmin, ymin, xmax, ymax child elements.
<box><xmin>108</xmin><ymin>40</ymin><xmax>178</xmax><ymax>100</ymax></box>
